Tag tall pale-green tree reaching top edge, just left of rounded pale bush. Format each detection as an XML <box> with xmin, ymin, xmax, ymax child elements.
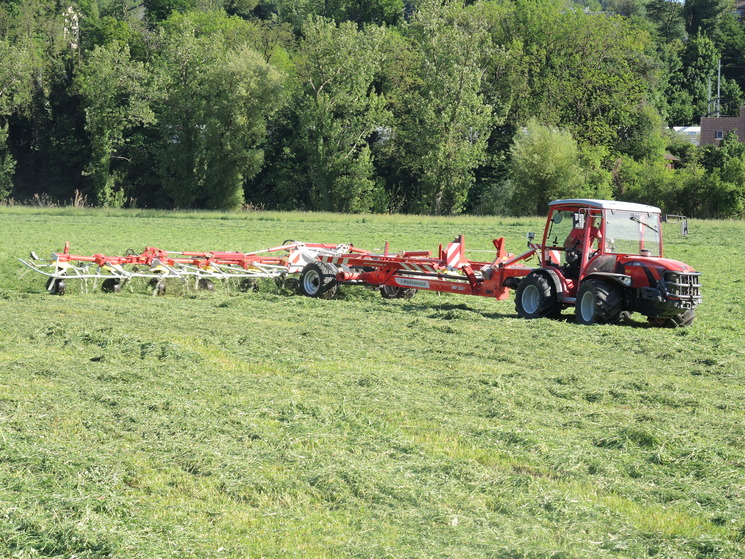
<box><xmin>397</xmin><ymin>0</ymin><xmax>493</xmax><ymax>214</ymax></box>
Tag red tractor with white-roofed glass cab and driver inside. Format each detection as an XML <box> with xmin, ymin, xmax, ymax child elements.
<box><xmin>510</xmin><ymin>200</ymin><xmax>701</xmax><ymax>326</ymax></box>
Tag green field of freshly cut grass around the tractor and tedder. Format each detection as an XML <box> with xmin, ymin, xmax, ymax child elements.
<box><xmin>0</xmin><ymin>208</ymin><xmax>745</xmax><ymax>559</ymax></box>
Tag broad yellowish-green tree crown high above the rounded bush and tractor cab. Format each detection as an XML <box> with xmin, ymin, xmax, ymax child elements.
<box><xmin>504</xmin><ymin>0</ymin><xmax>654</xmax><ymax>146</ymax></box>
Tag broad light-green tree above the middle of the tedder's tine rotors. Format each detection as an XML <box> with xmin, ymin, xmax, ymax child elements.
<box><xmin>155</xmin><ymin>13</ymin><xmax>284</xmax><ymax>209</ymax></box>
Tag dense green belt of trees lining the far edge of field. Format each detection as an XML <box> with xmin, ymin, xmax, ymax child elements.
<box><xmin>0</xmin><ymin>0</ymin><xmax>745</xmax><ymax>217</ymax></box>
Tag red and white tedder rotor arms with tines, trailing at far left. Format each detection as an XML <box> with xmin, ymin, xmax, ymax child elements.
<box><xmin>19</xmin><ymin>241</ymin><xmax>354</xmax><ymax>295</ymax></box>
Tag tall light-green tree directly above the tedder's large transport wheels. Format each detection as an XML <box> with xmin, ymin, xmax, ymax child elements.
<box><xmin>292</xmin><ymin>17</ymin><xmax>390</xmax><ymax>212</ymax></box>
